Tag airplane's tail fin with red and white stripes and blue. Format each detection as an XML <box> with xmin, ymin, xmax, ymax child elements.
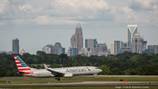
<box><xmin>14</xmin><ymin>56</ymin><xmax>32</xmax><ymax>75</ymax></box>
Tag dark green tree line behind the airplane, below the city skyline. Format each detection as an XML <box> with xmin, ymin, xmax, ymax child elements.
<box><xmin>0</xmin><ymin>51</ymin><xmax>158</xmax><ymax>76</ymax></box>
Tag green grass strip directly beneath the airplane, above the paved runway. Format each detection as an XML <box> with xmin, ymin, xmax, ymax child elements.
<box><xmin>0</xmin><ymin>77</ymin><xmax>158</xmax><ymax>84</ymax></box>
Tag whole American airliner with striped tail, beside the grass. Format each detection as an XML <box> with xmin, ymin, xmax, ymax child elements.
<box><xmin>13</xmin><ymin>55</ymin><xmax>102</xmax><ymax>80</ymax></box>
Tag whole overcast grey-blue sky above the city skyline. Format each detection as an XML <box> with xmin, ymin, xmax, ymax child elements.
<box><xmin>0</xmin><ymin>0</ymin><xmax>158</xmax><ymax>53</ymax></box>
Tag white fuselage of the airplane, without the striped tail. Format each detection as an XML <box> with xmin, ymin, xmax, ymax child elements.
<box><xmin>24</xmin><ymin>66</ymin><xmax>102</xmax><ymax>77</ymax></box>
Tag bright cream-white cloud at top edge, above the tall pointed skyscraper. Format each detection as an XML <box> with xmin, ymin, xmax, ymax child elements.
<box><xmin>51</xmin><ymin>0</ymin><xmax>109</xmax><ymax>16</ymax></box>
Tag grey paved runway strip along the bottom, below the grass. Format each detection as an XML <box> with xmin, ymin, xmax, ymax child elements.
<box><xmin>0</xmin><ymin>81</ymin><xmax>158</xmax><ymax>88</ymax></box>
